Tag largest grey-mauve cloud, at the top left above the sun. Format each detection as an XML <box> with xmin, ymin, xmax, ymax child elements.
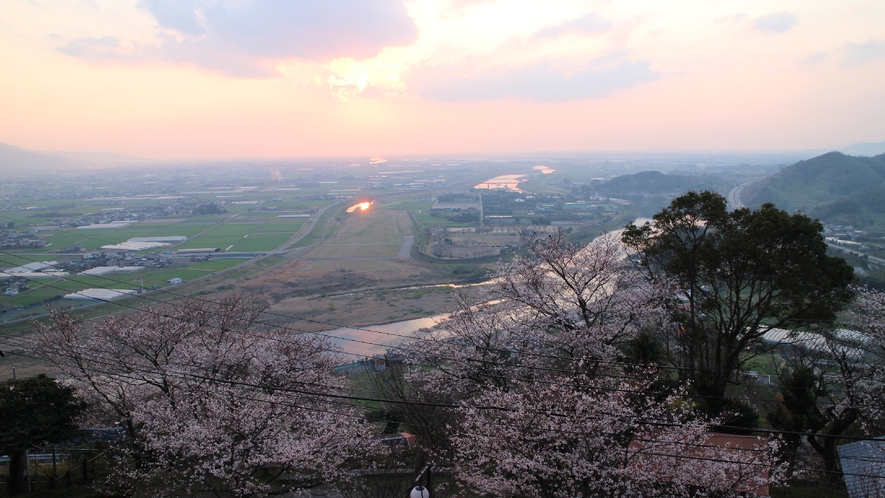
<box><xmin>62</xmin><ymin>0</ymin><xmax>418</xmax><ymax>77</ymax></box>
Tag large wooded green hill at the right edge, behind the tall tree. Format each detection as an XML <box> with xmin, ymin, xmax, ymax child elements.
<box><xmin>741</xmin><ymin>152</ymin><xmax>885</xmax><ymax>230</ymax></box>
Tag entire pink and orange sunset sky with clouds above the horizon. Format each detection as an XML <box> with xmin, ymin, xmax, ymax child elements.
<box><xmin>0</xmin><ymin>0</ymin><xmax>885</xmax><ymax>159</ymax></box>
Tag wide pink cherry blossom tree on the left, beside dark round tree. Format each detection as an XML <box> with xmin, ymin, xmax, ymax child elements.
<box><xmin>35</xmin><ymin>297</ymin><xmax>367</xmax><ymax>496</ymax></box>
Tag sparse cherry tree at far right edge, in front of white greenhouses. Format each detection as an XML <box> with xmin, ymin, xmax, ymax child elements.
<box><xmin>768</xmin><ymin>288</ymin><xmax>885</xmax><ymax>481</ymax></box>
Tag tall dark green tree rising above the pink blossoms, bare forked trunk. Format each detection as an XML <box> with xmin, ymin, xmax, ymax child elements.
<box><xmin>623</xmin><ymin>192</ymin><xmax>854</xmax><ymax>416</ymax></box>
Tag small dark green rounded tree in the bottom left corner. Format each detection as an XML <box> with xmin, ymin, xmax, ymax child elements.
<box><xmin>0</xmin><ymin>374</ymin><xmax>85</xmax><ymax>494</ymax></box>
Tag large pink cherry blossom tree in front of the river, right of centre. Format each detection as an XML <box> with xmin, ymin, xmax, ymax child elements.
<box><xmin>408</xmin><ymin>233</ymin><xmax>773</xmax><ymax>497</ymax></box>
